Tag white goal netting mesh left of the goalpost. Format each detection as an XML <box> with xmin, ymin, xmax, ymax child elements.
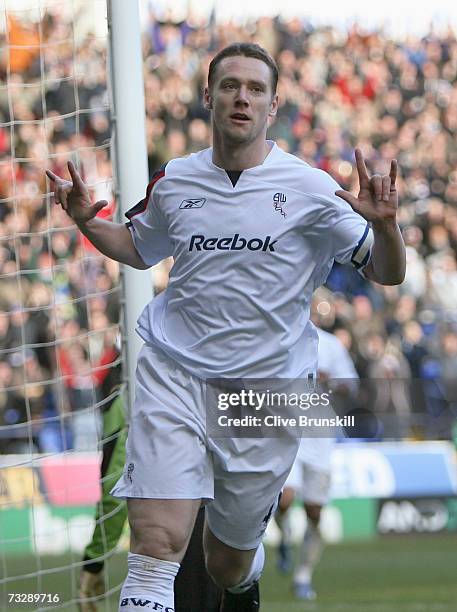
<box><xmin>0</xmin><ymin>0</ymin><xmax>126</xmax><ymax>610</ymax></box>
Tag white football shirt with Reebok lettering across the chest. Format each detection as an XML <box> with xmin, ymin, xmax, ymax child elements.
<box><xmin>127</xmin><ymin>143</ymin><xmax>373</xmax><ymax>378</ymax></box>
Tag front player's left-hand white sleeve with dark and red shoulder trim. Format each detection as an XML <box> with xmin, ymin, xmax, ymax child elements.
<box><xmin>125</xmin><ymin>166</ymin><xmax>173</xmax><ymax>266</ymax></box>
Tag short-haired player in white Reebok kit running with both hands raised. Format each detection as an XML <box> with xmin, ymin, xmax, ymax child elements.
<box><xmin>47</xmin><ymin>43</ymin><xmax>405</xmax><ymax>612</ymax></box>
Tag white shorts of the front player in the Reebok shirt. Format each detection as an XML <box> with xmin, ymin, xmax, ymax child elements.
<box><xmin>112</xmin><ymin>344</ymin><xmax>300</xmax><ymax>550</ymax></box>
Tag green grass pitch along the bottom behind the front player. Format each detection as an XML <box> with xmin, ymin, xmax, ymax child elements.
<box><xmin>0</xmin><ymin>534</ymin><xmax>457</xmax><ymax>612</ymax></box>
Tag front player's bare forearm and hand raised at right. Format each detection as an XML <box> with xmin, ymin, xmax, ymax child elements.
<box><xmin>335</xmin><ymin>149</ymin><xmax>406</xmax><ymax>285</ymax></box>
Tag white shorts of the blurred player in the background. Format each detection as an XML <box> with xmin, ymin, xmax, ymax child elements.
<box><xmin>285</xmin><ymin>457</ymin><xmax>331</xmax><ymax>506</ymax></box>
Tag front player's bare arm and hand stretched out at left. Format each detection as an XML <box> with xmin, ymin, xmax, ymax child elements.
<box><xmin>46</xmin><ymin>161</ymin><xmax>149</xmax><ymax>270</ymax></box>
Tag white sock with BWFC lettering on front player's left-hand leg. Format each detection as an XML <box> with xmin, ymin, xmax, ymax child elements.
<box><xmin>119</xmin><ymin>553</ymin><xmax>180</xmax><ymax>612</ymax></box>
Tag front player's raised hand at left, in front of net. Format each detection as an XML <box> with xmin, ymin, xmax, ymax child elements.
<box><xmin>46</xmin><ymin>161</ymin><xmax>108</xmax><ymax>223</ymax></box>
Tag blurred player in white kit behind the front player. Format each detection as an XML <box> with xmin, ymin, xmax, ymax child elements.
<box><xmin>276</xmin><ymin>328</ymin><xmax>358</xmax><ymax>600</ymax></box>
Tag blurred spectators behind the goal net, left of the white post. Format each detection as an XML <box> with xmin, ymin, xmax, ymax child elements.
<box><xmin>0</xmin><ymin>7</ymin><xmax>120</xmax><ymax>452</ymax></box>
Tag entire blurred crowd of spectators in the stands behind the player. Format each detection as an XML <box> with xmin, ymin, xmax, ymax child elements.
<box><xmin>0</xmin><ymin>7</ymin><xmax>457</xmax><ymax>452</ymax></box>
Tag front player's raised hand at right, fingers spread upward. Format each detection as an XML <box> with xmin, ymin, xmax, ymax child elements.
<box><xmin>335</xmin><ymin>149</ymin><xmax>398</xmax><ymax>225</ymax></box>
